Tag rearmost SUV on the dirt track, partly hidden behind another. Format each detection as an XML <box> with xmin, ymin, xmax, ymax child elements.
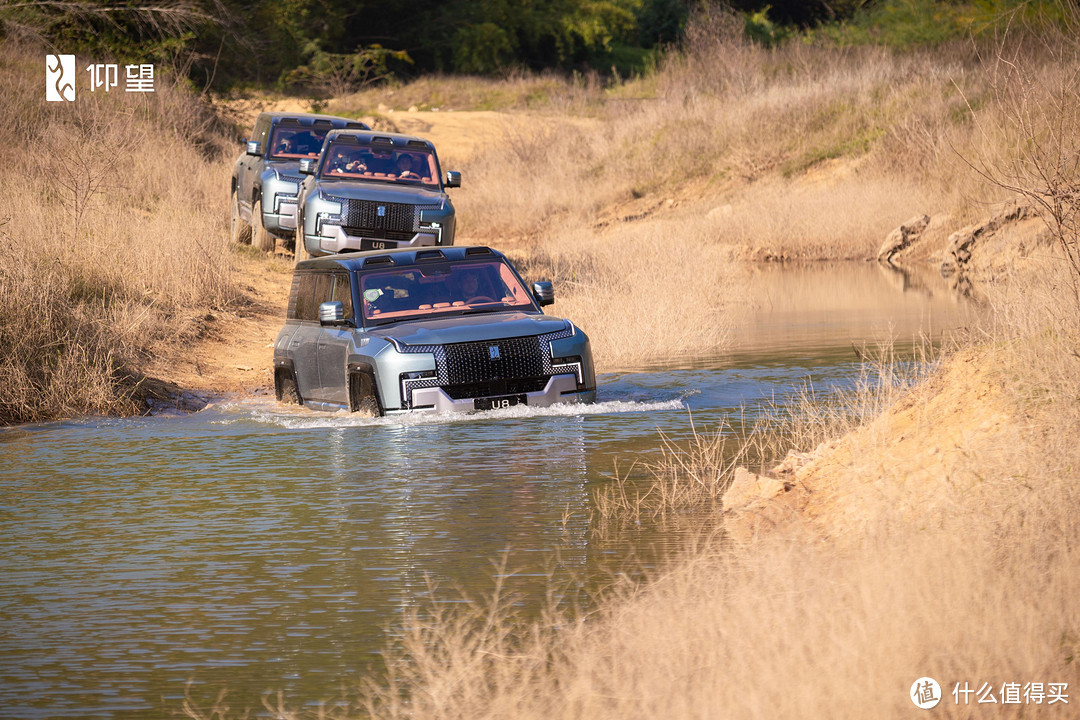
<box><xmin>230</xmin><ymin>112</ymin><xmax>367</xmax><ymax>250</ymax></box>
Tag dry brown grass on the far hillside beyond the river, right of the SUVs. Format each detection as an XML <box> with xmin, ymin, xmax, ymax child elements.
<box><xmin>434</xmin><ymin>37</ymin><xmax>1015</xmax><ymax>264</ymax></box>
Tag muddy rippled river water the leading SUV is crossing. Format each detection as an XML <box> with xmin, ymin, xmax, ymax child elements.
<box><xmin>0</xmin><ymin>263</ymin><xmax>971</xmax><ymax>718</ymax></box>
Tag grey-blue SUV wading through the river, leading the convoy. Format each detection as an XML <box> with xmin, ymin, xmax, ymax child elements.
<box><xmin>267</xmin><ymin>247</ymin><xmax>596</xmax><ymax>415</ymax></box>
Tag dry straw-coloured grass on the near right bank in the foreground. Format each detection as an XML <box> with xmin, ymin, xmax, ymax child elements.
<box><xmin>328</xmin><ymin>261</ymin><xmax>1080</xmax><ymax>719</ymax></box>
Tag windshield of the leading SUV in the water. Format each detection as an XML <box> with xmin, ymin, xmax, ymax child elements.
<box><xmin>361</xmin><ymin>260</ymin><xmax>535</xmax><ymax>325</ymax></box>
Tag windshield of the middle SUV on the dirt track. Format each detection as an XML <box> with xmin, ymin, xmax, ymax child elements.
<box><xmin>321</xmin><ymin>142</ymin><xmax>438</xmax><ymax>188</ymax></box>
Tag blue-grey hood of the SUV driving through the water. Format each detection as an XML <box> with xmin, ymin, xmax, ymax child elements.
<box><xmin>369</xmin><ymin>312</ymin><xmax>566</xmax><ymax>345</ymax></box>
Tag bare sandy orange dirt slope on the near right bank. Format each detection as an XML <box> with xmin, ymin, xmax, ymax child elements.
<box><xmin>724</xmin><ymin>350</ymin><xmax>1024</xmax><ymax>540</ymax></box>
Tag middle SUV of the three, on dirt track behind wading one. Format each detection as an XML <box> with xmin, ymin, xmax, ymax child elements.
<box><xmin>296</xmin><ymin>130</ymin><xmax>461</xmax><ymax>262</ymax></box>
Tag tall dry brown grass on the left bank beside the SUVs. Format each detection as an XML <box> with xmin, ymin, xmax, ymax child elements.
<box><xmin>0</xmin><ymin>42</ymin><xmax>239</xmax><ymax>422</ymax></box>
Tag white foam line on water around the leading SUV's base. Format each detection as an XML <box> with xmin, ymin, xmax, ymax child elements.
<box><xmin>207</xmin><ymin>397</ymin><xmax>686</xmax><ymax>430</ymax></box>
